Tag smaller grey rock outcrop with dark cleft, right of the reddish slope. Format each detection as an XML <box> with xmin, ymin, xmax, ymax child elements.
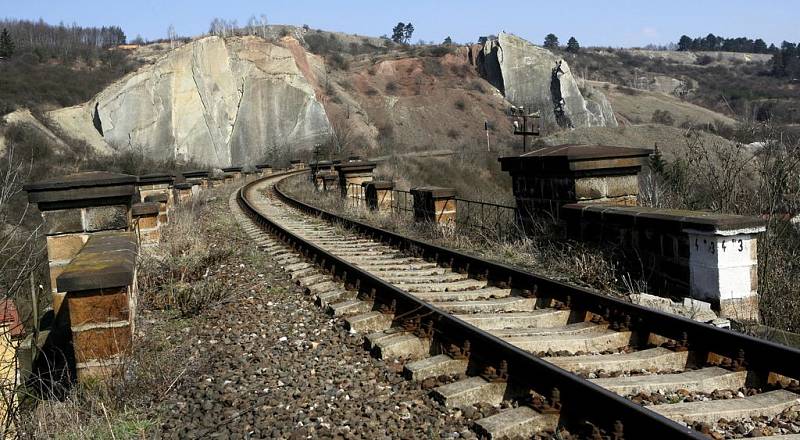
<box><xmin>475</xmin><ymin>33</ymin><xmax>617</xmax><ymax>128</ymax></box>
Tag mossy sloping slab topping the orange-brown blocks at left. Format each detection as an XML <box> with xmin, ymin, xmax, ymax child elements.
<box><xmin>56</xmin><ymin>232</ymin><xmax>137</xmax><ymax>292</ymax></box>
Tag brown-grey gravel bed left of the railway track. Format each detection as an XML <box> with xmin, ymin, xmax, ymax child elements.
<box><xmin>156</xmin><ymin>220</ymin><xmax>472</xmax><ymax>439</ymax></box>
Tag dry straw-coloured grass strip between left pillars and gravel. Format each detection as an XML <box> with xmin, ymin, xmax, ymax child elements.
<box><xmin>17</xmin><ymin>181</ymin><xmax>252</xmax><ymax>440</ymax></box>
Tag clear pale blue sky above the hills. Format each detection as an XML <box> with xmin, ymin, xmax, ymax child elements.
<box><xmin>0</xmin><ymin>0</ymin><xmax>800</xmax><ymax>47</ymax></box>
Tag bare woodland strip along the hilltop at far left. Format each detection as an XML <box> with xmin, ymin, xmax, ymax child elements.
<box><xmin>0</xmin><ymin>19</ymin><xmax>126</xmax><ymax>59</ymax></box>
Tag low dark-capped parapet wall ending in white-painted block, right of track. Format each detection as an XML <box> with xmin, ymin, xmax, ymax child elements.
<box><xmin>561</xmin><ymin>204</ymin><xmax>766</xmax><ymax>321</ymax></box>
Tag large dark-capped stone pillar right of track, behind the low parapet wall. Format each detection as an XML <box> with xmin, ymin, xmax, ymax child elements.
<box><xmin>499</xmin><ymin>145</ymin><xmax>652</xmax><ymax>223</ymax></box>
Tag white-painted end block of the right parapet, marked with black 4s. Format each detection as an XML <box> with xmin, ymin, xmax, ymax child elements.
<box><xmin>684</xmin><ymin>222</ymin><xmax>766</xmax><ymax>321</ymax></box>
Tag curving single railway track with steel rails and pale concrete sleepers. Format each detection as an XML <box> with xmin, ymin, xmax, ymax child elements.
<box><xmin>232</xmin><ymin>175</ymin><xmax>800</xmax><ymax>439</ymax></box>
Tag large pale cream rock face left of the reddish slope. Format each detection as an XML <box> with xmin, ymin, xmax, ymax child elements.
<box><xmin>51</xmin><ymin>37</ymin><xmax>331</xmax><ymax>166</ymax></box>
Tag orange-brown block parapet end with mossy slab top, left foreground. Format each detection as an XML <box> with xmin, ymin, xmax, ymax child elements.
<box><xmin>56</xmin><ymin>232</ymin><xmax>137</xmax><ymax>382</ymax></box>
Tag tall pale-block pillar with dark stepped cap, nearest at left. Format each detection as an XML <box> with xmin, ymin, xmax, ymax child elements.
<box><xmin>24</xmin><ymin>171</ymin><xmax>138</xmax><ymax>316</ymax></box>
